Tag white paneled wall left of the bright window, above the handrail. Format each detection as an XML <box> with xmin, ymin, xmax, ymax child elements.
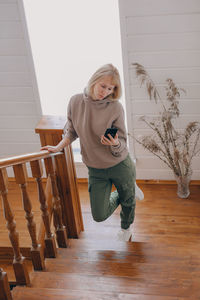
<box><xmin>0</xmin><ymin>0</ymin><xmax>42</xmax><ymax>175</ymax></box>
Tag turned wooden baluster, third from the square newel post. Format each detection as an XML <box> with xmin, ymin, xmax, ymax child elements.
<box><xmin>13</xmin><ymin>164</ymin><xmax>45</xmax><ymax>270</ymax></box>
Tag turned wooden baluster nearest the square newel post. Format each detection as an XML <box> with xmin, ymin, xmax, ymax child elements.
<box><xmin>45</xmin><ymin>157</ymin><xmax>67</xmax><ymax>248</ymax></box>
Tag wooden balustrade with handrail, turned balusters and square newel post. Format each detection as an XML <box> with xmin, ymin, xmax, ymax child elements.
<box><xmin>0</xmin><ymin>117</ymin><xmax>83</xmax><ymax>300</ymax></box>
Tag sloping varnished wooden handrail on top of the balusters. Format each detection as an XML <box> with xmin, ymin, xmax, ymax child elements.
<box><xmin>0</xmin><ymin>150</ymin><xmax>63</xmax><ymax>168</ymax></box>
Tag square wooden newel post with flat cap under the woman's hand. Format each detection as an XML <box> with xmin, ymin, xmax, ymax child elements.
<box><xmin>35</xmin><ymin>116</ymin><xmax>84</xmax><ymax>238</ymax></box>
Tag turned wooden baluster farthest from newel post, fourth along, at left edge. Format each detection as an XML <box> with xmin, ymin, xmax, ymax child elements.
<box><xmin>0</xmin><ymin>169</ymin><xmax>30</xmax><ymax>285</ymax></box>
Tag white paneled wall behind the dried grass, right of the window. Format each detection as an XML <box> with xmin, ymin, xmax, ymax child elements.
<box><xmin>119</xmin><ymin>0</ymin><xmax>200</xmax><ymax>179</ymax></box>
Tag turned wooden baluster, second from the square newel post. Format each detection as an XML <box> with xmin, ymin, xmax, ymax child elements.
<box><xmin>30</xmin><ymin>160</ymin><xmax>57</xmax><ymax>257</ymax></box>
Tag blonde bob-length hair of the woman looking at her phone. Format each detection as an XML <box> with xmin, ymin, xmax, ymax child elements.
<box><xmin>87</xmin><ymin>64</ymin><xmax>122</xmax><ymax>100</ymax></box>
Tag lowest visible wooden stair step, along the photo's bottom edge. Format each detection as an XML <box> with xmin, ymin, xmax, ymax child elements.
<box><xmin>12</xmin><ymin>287</ymin><xmax>186</xmax><ymax>300</ymax></box>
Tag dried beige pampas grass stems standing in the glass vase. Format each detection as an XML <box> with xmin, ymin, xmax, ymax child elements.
<box><xmin>129</xmin><ymin>63</ymin><xmax>200</xmax><ymax>176</ymax></box>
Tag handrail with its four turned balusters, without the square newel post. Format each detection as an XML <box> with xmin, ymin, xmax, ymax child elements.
<box><xmin>0</xmin><ymin>151</ymin><xmax>67</xmax><ymax>285</ymax></box>
